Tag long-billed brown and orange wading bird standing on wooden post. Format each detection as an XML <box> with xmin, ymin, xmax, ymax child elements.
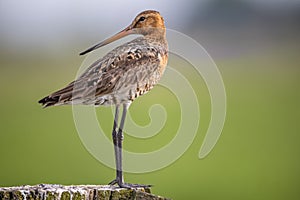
<box><xmin>39</xmin><ymin>10</ymin><xmax>168</xmax><ymax>188</ymax></box>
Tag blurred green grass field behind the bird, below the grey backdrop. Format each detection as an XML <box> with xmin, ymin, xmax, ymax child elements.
<box><xmin>0</xmin><ymin>42</ymin><xmax>300</xmax><ymax>199</ymax></box>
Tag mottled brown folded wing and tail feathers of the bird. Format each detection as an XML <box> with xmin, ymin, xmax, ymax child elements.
<box><xmin>39</xmin><ymin>37</ymin><xmax>163</xmax><ymax>107</ymax></box>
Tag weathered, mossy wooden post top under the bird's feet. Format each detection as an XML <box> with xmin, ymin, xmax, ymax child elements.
<box><xmin>0</xmin><ymin>184</ymin><xmax>167</xmax><ymax>200</ymax></box>
